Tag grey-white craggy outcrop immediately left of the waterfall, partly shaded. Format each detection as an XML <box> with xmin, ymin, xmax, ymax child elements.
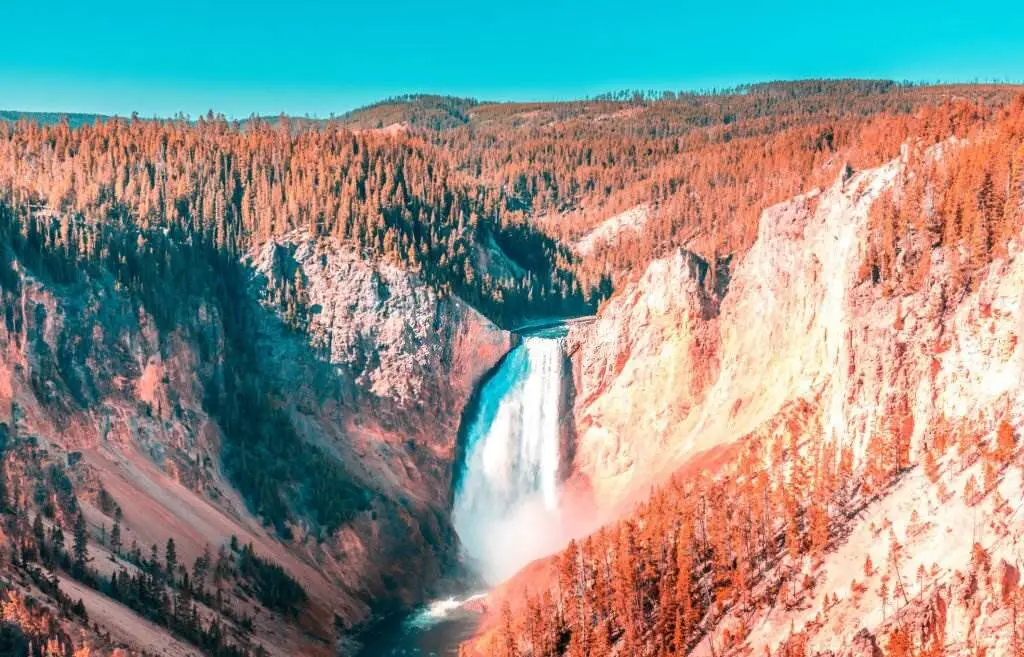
<box><xmin>253</xmin><ymin>233</ymin><xmax>512</xmax><ymax>511</ymax></box>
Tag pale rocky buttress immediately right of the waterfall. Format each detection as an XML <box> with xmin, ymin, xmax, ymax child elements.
<box><xmin>567</xmin><ymin>251</ymin><xmax>720</xmax><ymax>506</ymax></box>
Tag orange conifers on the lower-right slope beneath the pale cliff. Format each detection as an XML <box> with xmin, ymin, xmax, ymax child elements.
<box><xmin>490</xmin><ymin>409</ymin><xmax>1024</xmax><ymax>657</ymax></box>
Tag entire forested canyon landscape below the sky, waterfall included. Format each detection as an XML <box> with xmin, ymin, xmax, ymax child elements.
<box><xmin>0</xmin><ymin>81</ymin><xmax>1024</xmax><ymax>657</ymax></box>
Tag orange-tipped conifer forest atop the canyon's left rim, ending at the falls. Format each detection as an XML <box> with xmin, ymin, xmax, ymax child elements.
<box><xmin>0</xmin><ymin>110</ymin><xmax>600</xmax><ymax>331</ymax></box>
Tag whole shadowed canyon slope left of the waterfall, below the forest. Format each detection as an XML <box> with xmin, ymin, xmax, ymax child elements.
<box><xmin>0</xmin><ymin>202</ymin><xmax>509</xmax><ymax>655</ymax></box>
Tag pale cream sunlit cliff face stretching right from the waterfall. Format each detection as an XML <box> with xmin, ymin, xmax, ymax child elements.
<box><xmin>573</xmin><ymin>148</ymin><xmax>1021</xmax><ymax>505</ymax></box>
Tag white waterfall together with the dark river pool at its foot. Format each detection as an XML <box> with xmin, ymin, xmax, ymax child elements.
<box><xmin>360</xmin><ymin>325</ymin><xmax>567</xmax><ymax>657</ymax></box>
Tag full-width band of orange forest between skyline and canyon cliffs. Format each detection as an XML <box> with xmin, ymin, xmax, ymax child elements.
<box><xmin>0</xmin><ymin>81</ymin><xmax>1019</xmax><ymax>324</ymax></box>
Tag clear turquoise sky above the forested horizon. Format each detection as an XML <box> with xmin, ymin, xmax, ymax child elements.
<box><xmin>6</xmin><ymin>0</ymin><xmax>1024</xmax><ymax>117</ymax></box>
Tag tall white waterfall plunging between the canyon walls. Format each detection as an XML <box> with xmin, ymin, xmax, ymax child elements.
<box><xmin>453</xmin><ymin>335</ymin><xmax>564</xmax><ymax>584</ymax></box>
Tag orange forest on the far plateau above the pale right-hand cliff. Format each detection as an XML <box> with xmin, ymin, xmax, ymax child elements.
<box><xmin>342</xmin><ymin>81</ymin><xmax>1019</xmax><ymax>280</ymax></box>
